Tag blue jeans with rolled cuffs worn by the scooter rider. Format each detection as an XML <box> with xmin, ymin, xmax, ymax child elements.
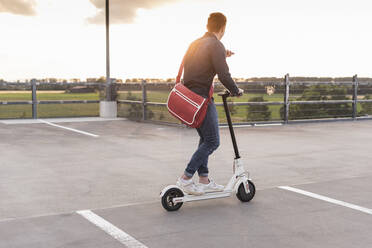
<box><xmin>185</xmin><ymin>98</ymin><xmax>220</xmax><ymax>177</ymax></box>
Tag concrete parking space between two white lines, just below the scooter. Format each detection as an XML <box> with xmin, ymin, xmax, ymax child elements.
<box><xmin>96</xmin><ymin>180</ymin><xmax>372</xmax><ymax>247</ymax></box>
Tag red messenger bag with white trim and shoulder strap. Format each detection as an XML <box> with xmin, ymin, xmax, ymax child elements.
<box><xmin>167</xmin><ymin>58</ymin><xmax>213</xmax><ymax>128</ymax></box>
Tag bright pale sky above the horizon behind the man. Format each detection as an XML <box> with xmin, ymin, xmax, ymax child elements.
<box><xmin>0</xmin><ymin>0</ymin><xmax>372</xmax><ymax>81</ymax></box>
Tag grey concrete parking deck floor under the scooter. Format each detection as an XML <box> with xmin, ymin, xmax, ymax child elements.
<box><xmin>0</xmin><ymin>119</ymin><xmax>372</xmax><ymax>248</ymax></box>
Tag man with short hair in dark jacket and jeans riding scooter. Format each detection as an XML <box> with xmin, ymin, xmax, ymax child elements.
<box><xmin>177</xmin><ymin>13</ymin><xmax>243</xmax><ymax>195</ymax></box>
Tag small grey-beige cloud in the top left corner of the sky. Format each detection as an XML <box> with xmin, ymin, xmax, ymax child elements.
<box><xmin>0</xmin><ymin>0</ymin><xmax>36</xmax><ymax>16</ymax></box>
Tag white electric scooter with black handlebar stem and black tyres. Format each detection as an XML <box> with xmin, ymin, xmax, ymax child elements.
<box><xmin>160</xmin><ymin>91</ymin><xmax>256</xmax><ymax>211</ymax></box>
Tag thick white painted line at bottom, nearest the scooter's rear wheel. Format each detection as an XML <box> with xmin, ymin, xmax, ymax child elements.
<box><xmin>76</xmin><ymin>210</ymin><xmax>147</xmax><ymax>248</ymax></box>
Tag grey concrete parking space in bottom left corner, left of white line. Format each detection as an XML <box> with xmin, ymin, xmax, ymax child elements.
<box><xmin>0</xmin><ymin>213</ymin><xmax>123</xmax><ymax>248</ymax></box>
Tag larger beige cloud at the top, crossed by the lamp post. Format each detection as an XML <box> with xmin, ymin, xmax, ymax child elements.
<box><xmin>88</xmin><ymin>0</ymin><xmax>180</xmax><ymax>24</ymax></box>
